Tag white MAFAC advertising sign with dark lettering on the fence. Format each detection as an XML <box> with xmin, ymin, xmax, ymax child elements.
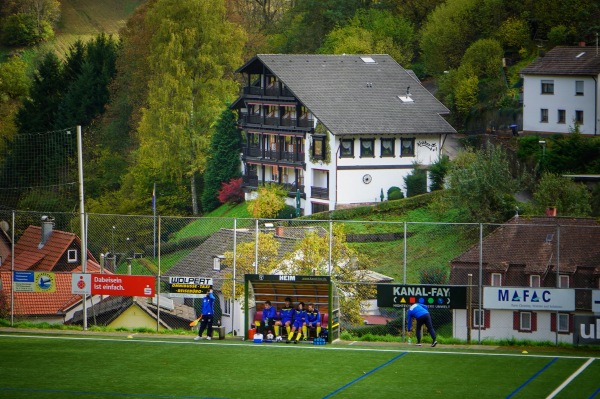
<box><xmin>483</xmin><ymin>287</ymin><xmax>575</xmax><ymax>312</ymax></box>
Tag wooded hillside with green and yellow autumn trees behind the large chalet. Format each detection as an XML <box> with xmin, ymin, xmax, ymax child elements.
<box><xmin>0</xmin><ymin>0</ymin><xmax>600</xmax><ymax>220</ymax></box>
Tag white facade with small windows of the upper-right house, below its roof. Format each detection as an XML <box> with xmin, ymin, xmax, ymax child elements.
<box><xmin>523</xmin><ymin>75</ymin><xmax>600</xmax><ymax>135</ymax></box>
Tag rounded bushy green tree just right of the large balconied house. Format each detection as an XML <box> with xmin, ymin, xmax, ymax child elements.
<box><xmin>447</xmin><ymin>146</ymin><xmax>520</xmax><ymax>223</ymax></box>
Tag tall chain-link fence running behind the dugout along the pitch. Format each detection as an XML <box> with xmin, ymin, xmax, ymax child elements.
<box><xmin>0</xmin><ymin>212</ymin><xmax>600</xmax><ymax>343</ymax></box>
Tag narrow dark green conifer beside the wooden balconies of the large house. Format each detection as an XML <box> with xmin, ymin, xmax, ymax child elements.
<box><xmin>202</xmin><ymin>109</ymin><xmax>242</xmax><ymax>212</ymax></box>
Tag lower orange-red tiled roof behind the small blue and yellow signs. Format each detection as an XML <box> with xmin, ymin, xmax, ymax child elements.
<box><xmin>0</xmin><ymin>272</ymin><xmax>81</xmax><ymax>315</ymax></box>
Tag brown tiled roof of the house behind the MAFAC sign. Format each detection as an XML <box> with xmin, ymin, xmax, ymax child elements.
<box><xmin>451</xmin><ymin>217</ymin><xmax>600</xmax><ymax>280</ymax></box>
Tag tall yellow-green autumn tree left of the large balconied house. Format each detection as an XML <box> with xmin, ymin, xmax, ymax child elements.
<box><xmin>132</xmin><ymin>0</ymin><xmax>244</xmax><ymax>214</ymax></box>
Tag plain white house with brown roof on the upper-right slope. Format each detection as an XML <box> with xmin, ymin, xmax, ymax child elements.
<box><xmin>520</xmin><ymin>46</ymin><xmax>600</xmax><ymax>135</ymax></box>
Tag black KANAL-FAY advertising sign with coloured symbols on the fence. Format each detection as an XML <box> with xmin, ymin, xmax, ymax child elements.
<box><xmin>377</xmin><ymin>284</ymin><xmax>467</xmax><ymax>309</ymax></box>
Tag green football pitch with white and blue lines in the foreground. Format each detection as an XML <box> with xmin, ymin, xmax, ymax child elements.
<box><xmin>0</xmin><ymin>332</ymin><xmax>600</xmax><ymax>399</ymax></box>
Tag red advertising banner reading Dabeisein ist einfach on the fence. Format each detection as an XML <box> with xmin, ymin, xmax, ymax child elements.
<box><xmin>71</xmin><ymin>273</ymin><xmax>156</xmax><ymax>297</ymax></box>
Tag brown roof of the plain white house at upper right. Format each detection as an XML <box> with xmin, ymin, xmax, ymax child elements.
<box><xmin>520</xmin><ymin>46</ymin><xmax>600</xmax><ymax>76</ymax></box>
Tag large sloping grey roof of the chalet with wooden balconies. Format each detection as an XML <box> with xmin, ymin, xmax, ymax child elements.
<box><xmin>238</xmin><ymin>54</ymin><xmax>456</xmax><ymax>135</ymax></box>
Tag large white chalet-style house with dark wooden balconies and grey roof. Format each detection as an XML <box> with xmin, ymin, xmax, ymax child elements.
<box><xmin>231</xmin><ymin>54</ymin><xmax>456</xmax><ymax>215</ymax></box>
